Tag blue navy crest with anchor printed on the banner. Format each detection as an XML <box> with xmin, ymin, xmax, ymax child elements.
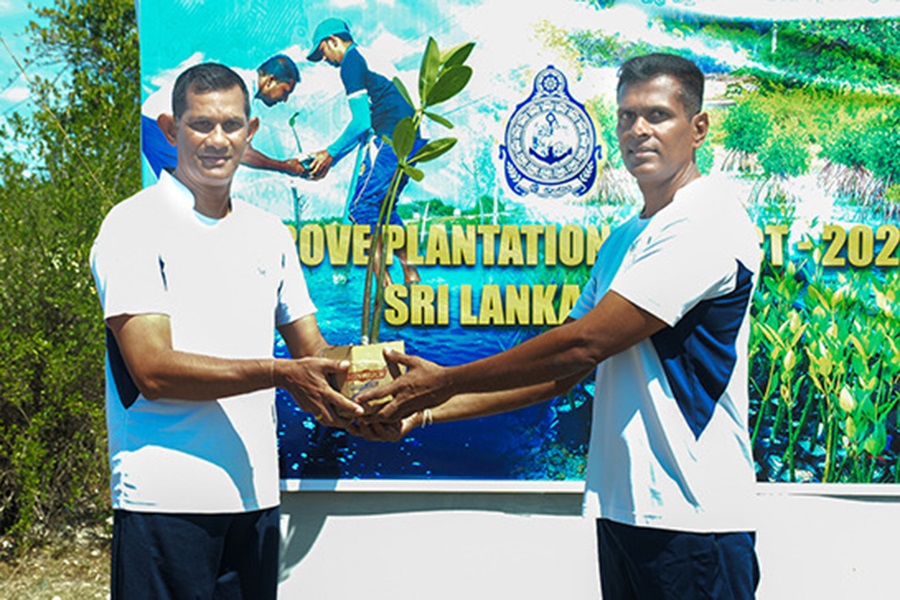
<box><xmin>500</xmin><ymin>65</ymin><xmax>603</xmax><ymax>197</ymax></box>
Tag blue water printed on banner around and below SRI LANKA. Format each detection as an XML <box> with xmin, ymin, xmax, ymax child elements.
<box><xmin>276</xmin><ymin>241</ymin><xmax>593</xmax><ymax>480</ymax></box>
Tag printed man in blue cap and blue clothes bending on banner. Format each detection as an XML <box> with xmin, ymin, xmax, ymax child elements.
<box><xmin>306</xmin><ymin>18</ymin><xmax>425</xmax><ymax>284</ymax></box>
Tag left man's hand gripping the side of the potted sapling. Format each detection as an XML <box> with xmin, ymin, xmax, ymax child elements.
<box><xmin>275</xmin><ymin>357</ymin><xmax>364</xmax><ymax>427</ymax></box>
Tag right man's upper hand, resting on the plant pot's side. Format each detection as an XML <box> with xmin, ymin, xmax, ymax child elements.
<box><xmin>356</xmin><ymin>348</ymin><xmax>453</xmax><ymax>423</ymax></box>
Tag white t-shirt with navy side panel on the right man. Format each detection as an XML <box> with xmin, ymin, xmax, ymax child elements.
<box><xmin>570</xmin><ymin>178</ymin><xmax>760</xmax><ymax>531</ymax></box>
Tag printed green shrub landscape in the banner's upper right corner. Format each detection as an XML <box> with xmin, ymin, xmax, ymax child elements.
<box><xmin>708</xmin><ymin>19</ymin><xmax>900</xmax><ymax>209</ymax></box>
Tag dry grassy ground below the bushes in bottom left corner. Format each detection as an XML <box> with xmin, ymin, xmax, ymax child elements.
<box><xmin>0</xmin><ymin>531</ymin><xmax>109</xmax><ymax>600</ymax></box>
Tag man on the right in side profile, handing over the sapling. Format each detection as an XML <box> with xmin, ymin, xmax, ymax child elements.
<box><xmin>353</xmin><ymin>54</ymin><xmax>760</xmax><ymax>600</ymax></box>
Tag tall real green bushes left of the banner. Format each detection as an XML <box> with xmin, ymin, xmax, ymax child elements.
<box><xmin>0</xmin><ymin>0</ymin><xmax>141</xmax><ymax>539</ymax></box>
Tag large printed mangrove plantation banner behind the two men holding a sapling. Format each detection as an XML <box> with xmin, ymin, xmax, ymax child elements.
<box><xmin>139</xmin><ymin>0</ymin><xmax>900</xmax><ymax>483</ymax></box>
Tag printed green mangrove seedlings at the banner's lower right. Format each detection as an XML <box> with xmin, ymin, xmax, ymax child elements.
<box><xmin>750</xmin><ymin>264</ymin><xmax>900</xmax><ymax>483</ymax></box>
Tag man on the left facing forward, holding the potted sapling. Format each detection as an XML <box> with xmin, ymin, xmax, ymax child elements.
<box><xmin>91</xmin><ymin>63</ymin><xmax>360</xmax><ymax>600</ymax></box>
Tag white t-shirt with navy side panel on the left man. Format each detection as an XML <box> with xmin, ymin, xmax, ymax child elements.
<box><xmin>91</xmin><ymin>171</ymin><xmax>315</xmax><ymax>513</ymax></box>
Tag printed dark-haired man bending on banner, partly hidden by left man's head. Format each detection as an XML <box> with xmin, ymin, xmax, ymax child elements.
<box><xmin>141</xmin><ymin>54</ymin><xmax>307</xmax><ymax>177</ymax></box>
